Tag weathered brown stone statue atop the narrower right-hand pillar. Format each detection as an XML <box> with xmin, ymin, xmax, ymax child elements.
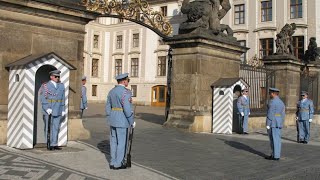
<box><xmin>275</xmin><ymin>23</ymin><xmax>296</xmax><ymax>55</ymax></box>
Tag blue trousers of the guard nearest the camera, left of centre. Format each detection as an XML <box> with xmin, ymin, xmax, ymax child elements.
<box><xmin>110</xmin><ymin>126</ymin><xmax>128</xmax><ymax>167</ymax></box>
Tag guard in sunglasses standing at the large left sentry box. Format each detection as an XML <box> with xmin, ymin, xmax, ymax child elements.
<box><xmin>40</xmin><ymin>70</ymin><xmax>66</xmax><ymax>150</ymax></box>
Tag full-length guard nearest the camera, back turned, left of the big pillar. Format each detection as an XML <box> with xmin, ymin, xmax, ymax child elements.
<box><xmin>106</xmin><ymin>73</ymin><xmax>135</xmax><ymax>169</ymax></box>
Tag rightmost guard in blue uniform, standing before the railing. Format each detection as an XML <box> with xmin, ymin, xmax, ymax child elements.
<box><xmin>296</xmin><ymin>91</ymin><xmax>314</xmax><ymax>144</ymax></box>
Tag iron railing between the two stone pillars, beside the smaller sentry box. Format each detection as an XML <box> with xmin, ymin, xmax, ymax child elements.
<box><xmin>239</xmin><ymin>64</ymin><xmax>275</xmax><ymax>111</ymax></box>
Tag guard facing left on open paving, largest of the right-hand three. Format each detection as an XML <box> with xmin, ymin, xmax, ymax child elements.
<box><xmin>266</xmin><ymin>88</ymin><xmax>285</xmax><ymax>160</ymax></box>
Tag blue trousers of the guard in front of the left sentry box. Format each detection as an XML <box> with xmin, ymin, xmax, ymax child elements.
<box><xmin>43</xmin><ymin>114</ymin><xmax>61</xmax><ymax>146</ymax></box>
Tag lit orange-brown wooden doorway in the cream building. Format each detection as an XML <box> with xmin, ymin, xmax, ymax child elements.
<box><xmin>151</xmin><ymin>85</ymin><xmax>167</xmax><ymax>107</ymax></box>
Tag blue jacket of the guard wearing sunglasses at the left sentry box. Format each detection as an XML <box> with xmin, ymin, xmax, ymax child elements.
<box><xmin>40</xmin><ymin>81</ymin><xmax>65</xmax><ymax>116</ymax></box>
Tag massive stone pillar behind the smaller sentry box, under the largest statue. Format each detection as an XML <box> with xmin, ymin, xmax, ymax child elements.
<box><xmin>164</xmin><ymin>35</ymin><xmax>247</xmax><ymax>132</ymax></box>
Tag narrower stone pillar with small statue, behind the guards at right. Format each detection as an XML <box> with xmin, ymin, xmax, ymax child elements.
<box><xmin>264</xmin><ymin>55</ymin><xmax>304</xmax><ymax>126</ymax></box>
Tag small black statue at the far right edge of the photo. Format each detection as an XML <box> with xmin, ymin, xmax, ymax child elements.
<box><xmin>303</xmin><ymin>37</ymin><xmax>320</xmax><ymax>64</ymax></box>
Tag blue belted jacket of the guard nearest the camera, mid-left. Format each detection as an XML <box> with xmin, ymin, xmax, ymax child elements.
<box><xmin>106</xmin><ymin>85</ymin><xmax>134</xmax><ymax>128</ymax></box>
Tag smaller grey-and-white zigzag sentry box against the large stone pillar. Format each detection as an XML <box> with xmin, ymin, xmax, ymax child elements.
<box><xmin>212</xmin><ymin>78</ymin><xmax>248</xmax><ymax>134</ymax></box>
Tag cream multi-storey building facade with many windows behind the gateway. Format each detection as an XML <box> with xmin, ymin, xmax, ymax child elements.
<box><xmin>84</xmin><ymin>0</ymin><xmax>320</xmax><ymax>105</ymax></box>
